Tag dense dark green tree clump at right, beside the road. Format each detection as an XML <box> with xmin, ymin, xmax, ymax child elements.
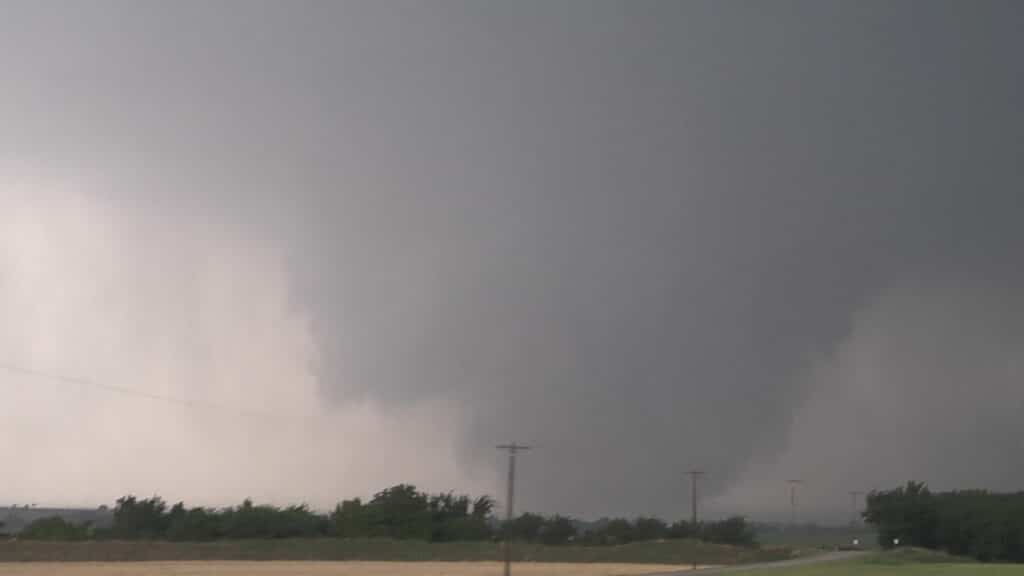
<box><xmin>863</xmin><ymin>482</ymin><xmax>1024</xmax><ymax>562</ymax></box>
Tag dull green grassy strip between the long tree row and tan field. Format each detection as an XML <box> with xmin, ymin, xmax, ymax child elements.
<box><xmin>0</xmin><ymin>539</ymin><xmax>790</xmax><ymax>565</ymax></box>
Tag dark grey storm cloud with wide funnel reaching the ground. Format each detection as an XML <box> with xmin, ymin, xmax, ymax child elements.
<box><xmin>0</xmin><ymin>2</ymin><xmax>1024</xmax><ymax>516</ymax></box>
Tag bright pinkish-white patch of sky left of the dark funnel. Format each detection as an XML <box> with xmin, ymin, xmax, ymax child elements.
<box><xmin>0</xmin><ymin>164</ymin><xmax>496</xmax><ymax>507</ymax></box>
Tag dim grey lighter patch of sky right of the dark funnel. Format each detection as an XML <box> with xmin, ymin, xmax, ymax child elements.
<box><xmin>714</xmin><ymin>277</ymin><xmax>1024</xmax><ymax>520</ymax></box>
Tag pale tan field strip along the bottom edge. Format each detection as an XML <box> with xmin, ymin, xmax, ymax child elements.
<box><xmin>0</xmin><ymin>562</ymin><xmax>700</xmax><ymax>576</ymax></box>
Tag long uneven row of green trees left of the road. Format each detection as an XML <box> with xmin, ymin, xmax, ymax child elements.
<box><xmin>17</xmin><ymin>484</ymin><xmax>754</xmax><ymax>545</ymax></box>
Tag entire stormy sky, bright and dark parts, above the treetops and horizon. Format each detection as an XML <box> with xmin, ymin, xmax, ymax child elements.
<box><xmin>0</xmin><ymin>1</ymin><xmax>1024</xmax><ymax>519</ymax></box>
